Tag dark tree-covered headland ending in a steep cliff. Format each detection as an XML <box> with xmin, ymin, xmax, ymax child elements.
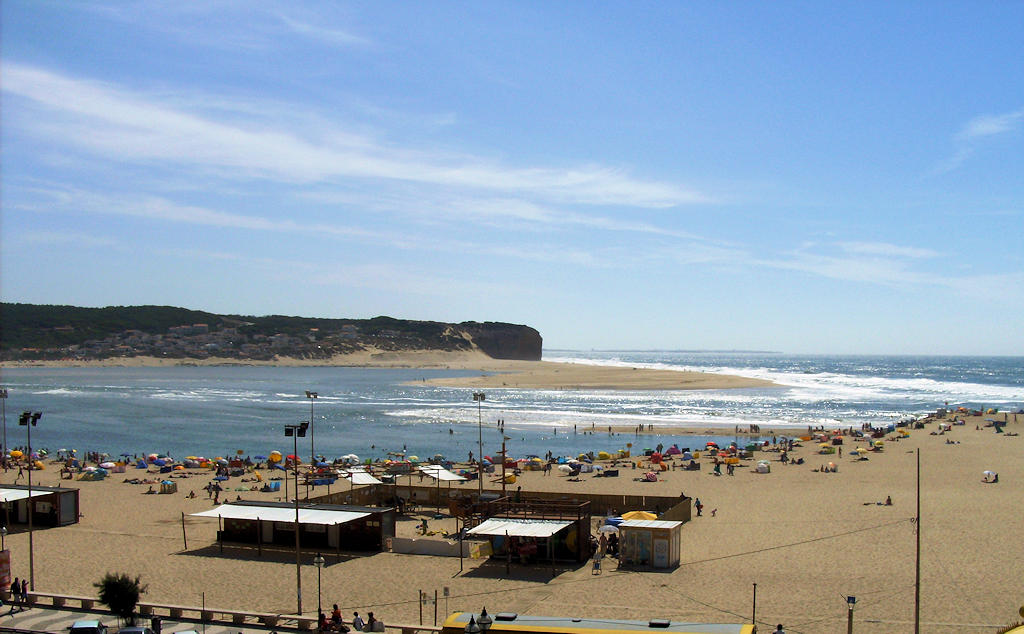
<box><xmin>0</xmin><ymin>303</ymin><xmax>543</xmax><ymax>363</ymax></box>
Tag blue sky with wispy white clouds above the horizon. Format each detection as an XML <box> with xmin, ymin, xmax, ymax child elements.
<box><xmin>0</xmin><ymin>0</ymin><xmax>1024</xmax><ymax>354</ymax></box>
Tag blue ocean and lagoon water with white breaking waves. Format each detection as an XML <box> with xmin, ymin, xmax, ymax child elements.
<box><xmin>2</xmin><ymin>350</ymin><xmax>1024</xmax><ymax>459</ymax></box>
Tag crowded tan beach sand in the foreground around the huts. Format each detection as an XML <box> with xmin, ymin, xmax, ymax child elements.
<box><xmin>0</xmin><ymin>417</ymin><xmax>1024</xmax><ymax>633</ymax></box>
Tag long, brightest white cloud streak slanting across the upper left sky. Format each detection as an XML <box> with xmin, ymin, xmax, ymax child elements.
<box><xmin>3</xmin><ymin>62</ymin><xmax>712</xmax><ymax>208</ymax></box>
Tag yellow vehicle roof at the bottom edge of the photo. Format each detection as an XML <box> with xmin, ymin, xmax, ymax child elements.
<box><xmin>441</xmin><ymin>612</ymin><xmax>758</xmax><ymax>634</ymax></box>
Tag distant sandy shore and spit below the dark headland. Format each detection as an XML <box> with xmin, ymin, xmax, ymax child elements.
<box><xmin>3</xmin><ymin>349</ymin><xmax>778</xmax><ymax>390</ymax></box>
